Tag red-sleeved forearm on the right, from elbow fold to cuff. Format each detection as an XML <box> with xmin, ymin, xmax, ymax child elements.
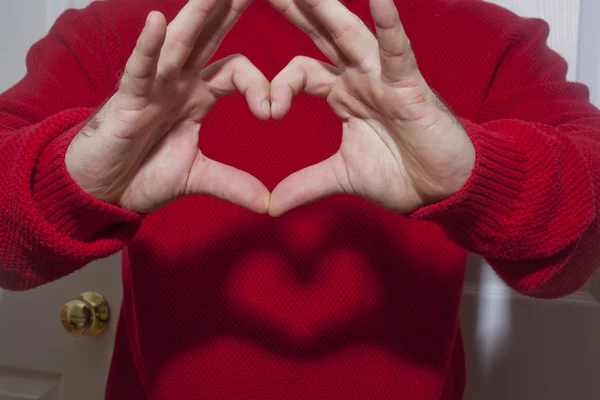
<box><xmin>413</xmin><ymin>120</ymin><xmax>600</xmax><ymax>297</ymax></box>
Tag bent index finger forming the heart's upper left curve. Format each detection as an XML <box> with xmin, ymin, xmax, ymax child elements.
<box><xmin>201</xmin><ymin>54</ymin><xmax>271</xmax><ymax>119</ymax></box>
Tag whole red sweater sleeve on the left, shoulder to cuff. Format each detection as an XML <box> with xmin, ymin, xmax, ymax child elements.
<box><xmin>0</xmin><ymin>2</ymin><xmax>143</xmax><ymax>290</ymax></box>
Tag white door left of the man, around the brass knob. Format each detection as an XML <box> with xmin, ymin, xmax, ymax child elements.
<box><xmin>0</xmin><ymin>4</ymin><xmax>116</xmax><ymax>400</ymax></box>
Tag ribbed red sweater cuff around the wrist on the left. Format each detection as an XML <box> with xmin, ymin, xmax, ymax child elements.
<box><xmin>32</xmin><ymin>121</ymin><xmax>140</xmax><ymax>242</ymax></box>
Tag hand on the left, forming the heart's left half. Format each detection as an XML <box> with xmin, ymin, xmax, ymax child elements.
<box><xmin>65</xmin><ymin>0</ymin><xmax>271</xmax><ymax>213</ymax></box>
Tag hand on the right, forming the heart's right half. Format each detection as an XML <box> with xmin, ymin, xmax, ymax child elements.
<box><xmin>269</xmin><ymin>0</ymin><xmax>475</xmax><ymax>216</ymax></box>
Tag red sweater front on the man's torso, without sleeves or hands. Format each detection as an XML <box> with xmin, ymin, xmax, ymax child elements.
<box><xmin>108</xmin><ymin>1</ymin><xmax>482</xmax><ymax>400</ymax></box>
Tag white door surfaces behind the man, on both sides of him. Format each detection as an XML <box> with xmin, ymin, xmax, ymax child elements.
<box><xmin>0</xmin><ymin>0</ymin><xmax>600</xmax><ymax>400</ymax></box>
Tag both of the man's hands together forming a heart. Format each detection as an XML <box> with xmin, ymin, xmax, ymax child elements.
<box><xmin>65</xmin><ymin>0</ymin><xmax>475</xmax><ymax>216</ymax></box>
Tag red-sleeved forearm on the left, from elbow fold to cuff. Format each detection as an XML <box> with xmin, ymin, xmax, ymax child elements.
<box><xmin>0</xmin><ymin>109</ymin><xmax>140</xmax><ymax>290</ymax></box>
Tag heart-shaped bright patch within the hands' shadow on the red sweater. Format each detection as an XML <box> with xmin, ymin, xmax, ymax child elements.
<box><xmin>226</xmin><ymin>249</ymin><xmax>381</xmax><ymax>343</ymax></box>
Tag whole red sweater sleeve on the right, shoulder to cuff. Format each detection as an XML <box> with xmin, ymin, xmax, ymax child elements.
<box><xmin>412</xmin><ymin>7</ymin><xmax>600</xmax><ymax>298</ymax></box>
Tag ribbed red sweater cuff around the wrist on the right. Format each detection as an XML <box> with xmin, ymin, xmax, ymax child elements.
<box><xmin>411</xmin><ymin>119</ymin><xmax>527</xmax><ymax>248</ymax></box>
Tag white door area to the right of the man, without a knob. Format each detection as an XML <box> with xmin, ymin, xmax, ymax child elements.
<box><xmin>461</xmin><ymin>0</ymin><xmax>600</xmax><ymax>400</ymax></box>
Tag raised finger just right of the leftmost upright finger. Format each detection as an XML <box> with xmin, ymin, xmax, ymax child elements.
<box><xmin>157</xmin><ymin>0</ymin><xmax>219</xmax><ymax>80</ymax></box>
